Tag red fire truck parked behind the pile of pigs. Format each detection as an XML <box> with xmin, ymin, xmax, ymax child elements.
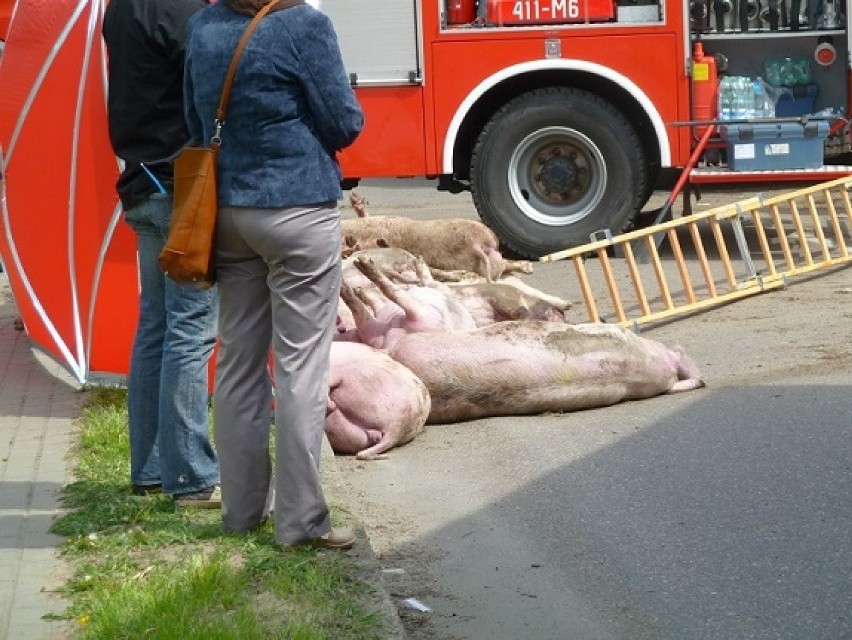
<box><xmin>320</xmin><ymin>0</ymin><xmax>852</xmax><ymax>257</ymax></box>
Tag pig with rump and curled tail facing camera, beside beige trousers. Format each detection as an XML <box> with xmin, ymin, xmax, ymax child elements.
<box><xmin>325</xmin><ymin>342</ymin><xmax>430</xmax><ymax>460</ymax></box>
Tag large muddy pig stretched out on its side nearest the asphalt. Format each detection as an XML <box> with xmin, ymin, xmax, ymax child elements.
<box><xmin>388</xmin><ymin>320</ymin><xmax>704</xmax><ymax>424</ymax></box>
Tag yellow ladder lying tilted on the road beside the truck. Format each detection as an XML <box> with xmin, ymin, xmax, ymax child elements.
<box><xmin>541</xmin><ymin>176</ymin><xmax>852</xmax><ymax>327</ymax></box>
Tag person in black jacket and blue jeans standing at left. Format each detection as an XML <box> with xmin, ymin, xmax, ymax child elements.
<box><xmin>103</xmin><ymin>0</ymin><xmax>221</xmax><ymax>508</ymax></box>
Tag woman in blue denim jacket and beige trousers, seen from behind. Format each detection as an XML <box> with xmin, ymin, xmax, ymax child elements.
<box><xmin>184</xmin><ymin>0</ymin><xmax>364</xmax><ymax>549</ymax></box>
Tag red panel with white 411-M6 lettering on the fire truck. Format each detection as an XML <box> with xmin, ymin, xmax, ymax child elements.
<box><xmin>488</xmin><ymin>0</ymin><xmax>615</xmax><ymax>25</ymax></box>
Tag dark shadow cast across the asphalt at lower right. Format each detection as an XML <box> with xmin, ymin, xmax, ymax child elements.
<box><xmin>392</xmin><ymin>385</ymin><xmax>852</xmax><ymax>640</ymax></box>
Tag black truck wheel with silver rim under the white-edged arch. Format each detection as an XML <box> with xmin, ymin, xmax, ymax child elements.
<box><xmin>471</xmin><ymin>87</ymin><xmax>649</xmax><ymax>259</ymax></box>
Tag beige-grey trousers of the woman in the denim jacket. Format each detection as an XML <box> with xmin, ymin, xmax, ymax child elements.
<box><xmin>213</xmin><ymin>202</ymin><xmax>340</xmax><ymax>544</ymax></box>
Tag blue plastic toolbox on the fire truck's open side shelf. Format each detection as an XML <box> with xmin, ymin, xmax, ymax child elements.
<box><xmin>719</xmin><ymin>120</ymin><xmax>828</xmax><ymax>171</ymax></box>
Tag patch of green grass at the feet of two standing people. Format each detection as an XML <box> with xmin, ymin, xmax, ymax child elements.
<box><xmin>52</xmin><ymin>388</ymin><xmax>390</xmax><ymax>640</ymax></box>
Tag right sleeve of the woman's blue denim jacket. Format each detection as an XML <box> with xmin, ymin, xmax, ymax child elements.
<box><xmin>294</xmin><ymin>10</ymin><xmax>364</xmax><ymax>151</ymax></box>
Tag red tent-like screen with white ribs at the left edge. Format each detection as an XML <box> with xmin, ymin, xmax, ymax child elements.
<box><xmin>0</xmin><ymin>0</ymin><xmax>139</xmax><ymax>383</ymax></box>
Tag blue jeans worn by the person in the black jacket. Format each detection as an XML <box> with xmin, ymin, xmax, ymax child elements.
<box><xmin>124</xmin><ymin>193</ymin><xmax>219</xmax><ymax>495</ymax></box>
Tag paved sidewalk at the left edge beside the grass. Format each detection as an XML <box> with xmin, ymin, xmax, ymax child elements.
<box><xmin>0</xmin><ymin>273</ymin><xmax>75</xmax><ymax>640</ymax></box>
